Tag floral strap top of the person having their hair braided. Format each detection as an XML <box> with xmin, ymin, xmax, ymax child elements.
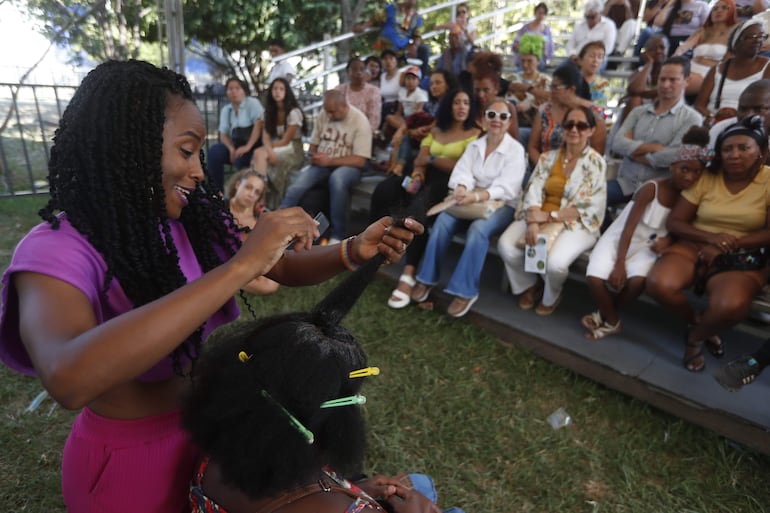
<box><xmin>189</xmin><ymin>458</ymin><xmax>385</xmax><ymax>513</ymax></box>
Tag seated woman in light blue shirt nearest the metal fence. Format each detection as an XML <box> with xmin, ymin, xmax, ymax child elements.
<box><xmin>207</xmin><ymin>77</ymin><xmax>265</xmax><ymax>193</ymax></box>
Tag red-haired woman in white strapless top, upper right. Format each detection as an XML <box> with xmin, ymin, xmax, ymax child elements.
<box><xmin>674</xmin><ymin>0</ymin><xmax>738</xmax><ymax>95</ymax></box>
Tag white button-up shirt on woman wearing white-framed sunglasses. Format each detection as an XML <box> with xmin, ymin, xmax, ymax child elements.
<box><xmin>449</xmin><ymin>133</ymin><xmax>526</xmax><ymax>208</ymax></box>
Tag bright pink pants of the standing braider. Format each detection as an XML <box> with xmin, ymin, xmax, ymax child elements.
<box><xmin>62</xmin><ymin>408</ymin><xmax>198</xmax><ymax>513</ymax></box>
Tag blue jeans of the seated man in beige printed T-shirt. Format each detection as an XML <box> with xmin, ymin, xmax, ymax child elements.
<box><xmin>278</xmin><ymin>166</ymin><xmax>361</xmax><ymax>240</ymax></box>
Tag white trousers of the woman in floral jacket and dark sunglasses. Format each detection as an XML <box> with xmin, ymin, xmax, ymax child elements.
<box><xmin>497</xmin><ymin>220</ymin><xmax>598</xmax><ymax>306</ymax></box>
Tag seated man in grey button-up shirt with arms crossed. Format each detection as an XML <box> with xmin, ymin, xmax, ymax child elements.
<box><xmin>607</xmin><ymin>56</ymin><xmax>703</xmax><ymax>206</ymax></box>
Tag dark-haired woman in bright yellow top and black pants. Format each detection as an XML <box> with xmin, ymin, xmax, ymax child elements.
<box><xmin>370</xmin><ymin>89</ymin><xmax>481</xmax><ymax>308</ymax></box>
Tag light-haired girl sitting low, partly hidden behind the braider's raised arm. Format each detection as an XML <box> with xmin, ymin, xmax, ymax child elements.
<box><xmin>225</xmin><ymin>170</ymin><xmax>282</xmax><ymax>296</ymax></box>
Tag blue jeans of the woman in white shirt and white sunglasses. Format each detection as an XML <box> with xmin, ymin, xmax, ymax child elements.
<box><xmin>417</xmin><ymin>205</ymin><xmax>514</xmax><ymax>299</ymax></box>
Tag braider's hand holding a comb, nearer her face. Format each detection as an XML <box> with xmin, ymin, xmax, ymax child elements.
<box><xmin>230</xmin><ymin>207</ymin><xmax>320</xmax><ymax>281</ymax></box>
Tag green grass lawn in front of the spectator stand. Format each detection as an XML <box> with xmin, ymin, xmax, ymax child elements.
<box><xmin>0</xmin><ymin>194</ymin><xmax>770</xmax><ymax>513</ymax></box>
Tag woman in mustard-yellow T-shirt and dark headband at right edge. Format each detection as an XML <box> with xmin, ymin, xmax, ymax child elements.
<box><xmin>647</xmin><ymin>116</ymin><xmax>770</xmax><ymax>372</ymax></box>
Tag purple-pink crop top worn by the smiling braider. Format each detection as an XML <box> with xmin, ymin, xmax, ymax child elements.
<box><xmin>0</xmin><ymin>214</ymin><xmax>239</xmax><ymax>381</ymax></box>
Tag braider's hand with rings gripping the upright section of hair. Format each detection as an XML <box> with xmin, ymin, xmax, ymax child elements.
<box><xmin>352</xmin><ymin>217</ymin><xmax>425</xmax><ymax>264</ymax></box>
